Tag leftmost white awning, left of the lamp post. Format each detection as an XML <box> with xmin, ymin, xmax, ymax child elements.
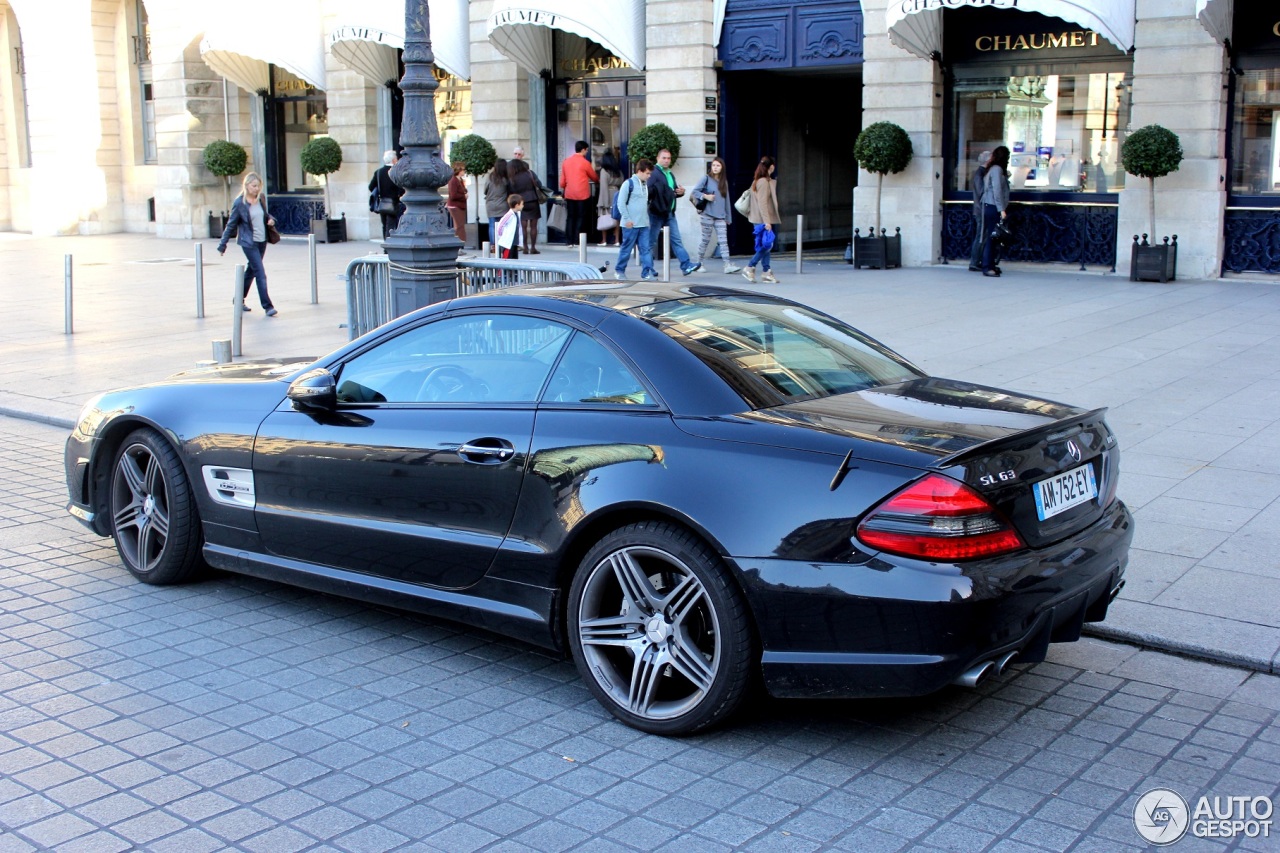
<box><xmin>200</xmin><ymin>0</ymin><xmax>325</xmax><ymax>92</ymax></box>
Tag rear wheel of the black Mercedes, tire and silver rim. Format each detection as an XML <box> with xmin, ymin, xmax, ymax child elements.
<box><xmin>568</xmin><ymin>521</ymin><xmax>755</xmax><ymax>735</ymax></box>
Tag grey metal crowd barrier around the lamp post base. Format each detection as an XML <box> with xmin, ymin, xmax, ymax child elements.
<box><xmin>346</xmin><ymin>255</ymin><xmax>600</xmax><ymax>341</ymax></box>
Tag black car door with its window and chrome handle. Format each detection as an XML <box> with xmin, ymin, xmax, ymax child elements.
<box><xmin>253</xmin><ymin>311</ymin><xmax>571</xmax><ymax>589</ymax></box>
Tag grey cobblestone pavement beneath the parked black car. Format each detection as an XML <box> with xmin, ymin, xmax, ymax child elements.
<box><xmin>0</xmin><ymin>419</ymin><xmax>1280</xmax><ymax>853</ymax></box>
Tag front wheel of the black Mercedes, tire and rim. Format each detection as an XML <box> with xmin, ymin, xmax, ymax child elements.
<box><xmin>109</xmin><ymin>429</ymin><xmax>204</xmax><ymax>585</ymax></box>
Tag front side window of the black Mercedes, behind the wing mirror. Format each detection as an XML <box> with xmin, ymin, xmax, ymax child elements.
<box><xmin>338</xmin><ymin>314</ymin><xmax>572</xmax><ymax>405</ymax></box>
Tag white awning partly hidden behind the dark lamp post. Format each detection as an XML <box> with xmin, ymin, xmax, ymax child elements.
<box><xmin>329</xmin><ymin>0</ymin><xmax>471</xmax><ymax>86</ymax></box>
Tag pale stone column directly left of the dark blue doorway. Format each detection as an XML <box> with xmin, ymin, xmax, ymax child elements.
<box><xmin>645</xmin><ymin>0</ymin><xmax>718</xmax><ymax>252</ymax></box>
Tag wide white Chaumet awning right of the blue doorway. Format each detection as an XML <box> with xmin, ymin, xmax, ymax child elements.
<box><xmin>884</xmin><ymin>0</ymin><xmax>1135</xmax><ymax>59</ymax></box>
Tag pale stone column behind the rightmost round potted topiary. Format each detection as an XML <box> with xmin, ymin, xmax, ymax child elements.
<box><xmin>1116</xmin><ymin>0</ymin><xmax>1228</xmax><ymax>278</ymax></box>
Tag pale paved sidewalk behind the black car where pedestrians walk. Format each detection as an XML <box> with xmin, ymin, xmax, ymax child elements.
<box><xmin>0</xmin><ymin>234</ymin><xmax>1280</xmax><ymax>672</ymax></box>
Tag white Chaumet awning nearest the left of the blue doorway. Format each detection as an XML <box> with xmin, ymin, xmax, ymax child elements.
<box><xmin>489</xmin><ymin>0</ymin><xmax>645</xmax><ymax>74</ymax></box>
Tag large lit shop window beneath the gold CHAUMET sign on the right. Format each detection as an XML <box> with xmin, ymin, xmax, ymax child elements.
<box><xmin>950</xmin><ymin>68</ymin><xmax>1132</xmax><ymax>193</ymax></box>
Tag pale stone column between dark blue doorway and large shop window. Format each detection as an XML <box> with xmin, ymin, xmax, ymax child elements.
<box><xmin>850</xmin><ymin>0</ymin><xmax>943</xmax><ymax>266</ymax></box>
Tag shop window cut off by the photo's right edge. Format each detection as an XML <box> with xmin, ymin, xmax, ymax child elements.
<box><xmin>1231</xmin><ymin>68</ymin><xmax>1280</xmax><ymax>196</ymax></box>
